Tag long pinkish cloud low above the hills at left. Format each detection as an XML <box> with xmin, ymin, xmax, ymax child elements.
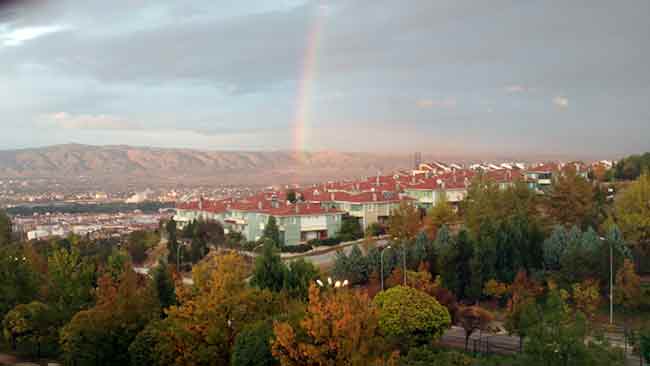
<box><xmin>46</xmin><ymin>112</ymin><xmax>141</xmax><ymax>130</ymax></box>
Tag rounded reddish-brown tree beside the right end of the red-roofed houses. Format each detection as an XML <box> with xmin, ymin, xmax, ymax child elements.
<box><xmin>546</xmin><ymin>169</ymin><xmax>597</xmax><ymax>229</ymax></box>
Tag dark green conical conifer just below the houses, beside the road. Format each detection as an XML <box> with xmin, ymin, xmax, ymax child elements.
<box><xmin>251</xmin><ymin>240</ymin><xmax>287</xmax><ymax>292</ymax></box>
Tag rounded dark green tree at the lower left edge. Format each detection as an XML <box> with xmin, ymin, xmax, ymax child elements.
<box><xmin>3</xmin><ymin>301</ymin><xmax>58</xmax><ymax>358</ymax></box>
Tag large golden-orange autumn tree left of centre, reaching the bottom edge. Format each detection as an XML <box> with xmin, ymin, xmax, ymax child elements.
<box><xmin>161</xmin><ymin>253</ymin><xmax>279</xmax><ymax>366</ymax></box>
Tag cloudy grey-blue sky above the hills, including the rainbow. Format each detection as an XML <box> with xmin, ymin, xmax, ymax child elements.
<box><xmin>0</xmin><ymin>0</ymin><xmax>650</xmax><ymax>156</ymax></box>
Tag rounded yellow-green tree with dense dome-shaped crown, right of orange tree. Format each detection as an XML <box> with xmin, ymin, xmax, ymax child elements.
<box><xmin>373</xmin><ymin>286</ymin><xmax>451</xmax><ymax>346</ymax></box>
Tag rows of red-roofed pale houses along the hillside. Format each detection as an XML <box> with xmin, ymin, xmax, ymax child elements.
<box><xmin>174</xmin><ymin>162</ymin><xmax>590</xmax><ymax>245</ymax></box>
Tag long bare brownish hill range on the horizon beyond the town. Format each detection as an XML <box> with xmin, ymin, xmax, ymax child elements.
<box><xmin>0</xmin><ymin>144</ymin><xmax>412</xmax><ymax>186</ymax></box>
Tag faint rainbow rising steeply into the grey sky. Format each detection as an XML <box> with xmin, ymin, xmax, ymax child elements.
<box><xmin>293</xmin><ymin>7</ymin><xmax>326</xmax><ymax>158</ymax></box>
